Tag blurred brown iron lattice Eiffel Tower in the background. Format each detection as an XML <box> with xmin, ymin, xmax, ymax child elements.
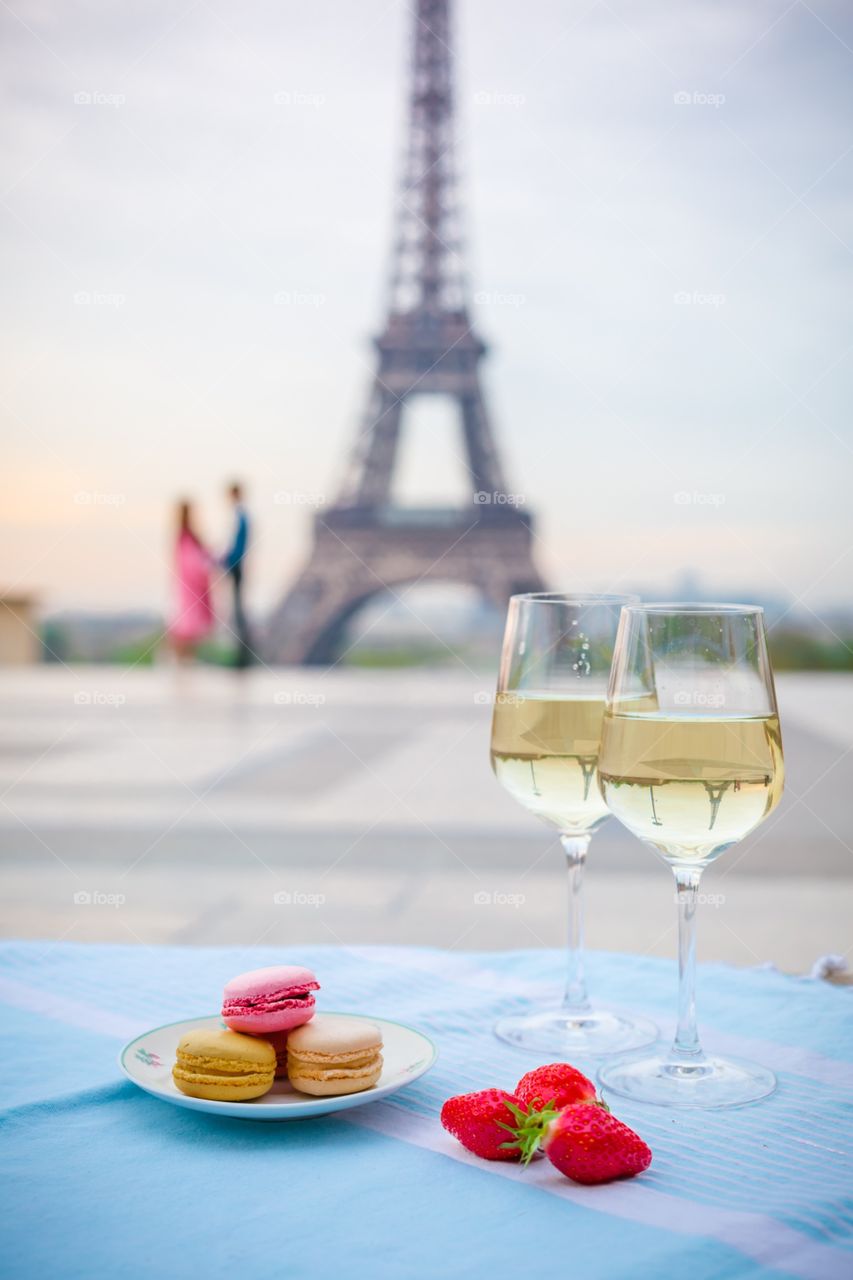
<box><xmin>266</xmin><ymin>0</ymin><xmax>542</xmax><ymax>664</ymax></box>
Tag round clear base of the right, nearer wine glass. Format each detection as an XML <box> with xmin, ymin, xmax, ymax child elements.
<box><xmin>598</xmin><ymin>1055</ymin><xmax>776</xmax><ymax>1110</ymax></box>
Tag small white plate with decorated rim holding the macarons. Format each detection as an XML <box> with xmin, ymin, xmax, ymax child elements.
<box><xmin>119</xmin><ymin>1010</ymin><xmax>438</xmax><ymax>1120</ymax></box>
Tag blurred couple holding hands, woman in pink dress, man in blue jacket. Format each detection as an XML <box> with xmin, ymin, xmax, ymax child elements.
<box><xmin>169</xmin><ymin>483</ymin><xmax>254</xmax><ymax>667</ymax></box>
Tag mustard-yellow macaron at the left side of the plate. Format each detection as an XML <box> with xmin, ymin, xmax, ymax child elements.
<box><xmin>172</xmin><ymin>1027</ymin><xmax>275</xmax><ymax>1102</ymax></box>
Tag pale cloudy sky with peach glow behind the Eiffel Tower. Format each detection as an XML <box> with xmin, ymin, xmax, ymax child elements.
<box><xmin>0</xmin><ymin>0</ymin><xmax>853</xmax><ymax>611</ymax></box>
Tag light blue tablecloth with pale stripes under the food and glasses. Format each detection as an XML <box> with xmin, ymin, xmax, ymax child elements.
<box><xmin>0</xmin><ymin>943</ymin><xmax>853</xmax><ymax>1280</ymax></box>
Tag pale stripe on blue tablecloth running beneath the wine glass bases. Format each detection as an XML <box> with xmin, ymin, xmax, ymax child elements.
<box><xmin>348</xmin><ymin>947</ymin><xmax>853</xmax><ymax>1089</ymax></box>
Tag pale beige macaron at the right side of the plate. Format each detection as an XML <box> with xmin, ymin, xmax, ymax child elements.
<box><xmin>287</xmin><ymin>1014</ymin><xmax>382</xmax><ymax>1097</ymax></box>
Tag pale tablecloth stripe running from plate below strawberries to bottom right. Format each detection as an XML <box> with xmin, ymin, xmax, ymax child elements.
<box><xmin>338</xmin><ymin>1102</ymin><xmax>850</xmax><ymax>1280</ymax></box>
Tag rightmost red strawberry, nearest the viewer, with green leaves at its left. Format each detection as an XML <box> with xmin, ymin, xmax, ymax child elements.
<box><xmin>542</xmin><ymin>1102</ymin><xmax>652</xmax><ymax>1184</ymax></box>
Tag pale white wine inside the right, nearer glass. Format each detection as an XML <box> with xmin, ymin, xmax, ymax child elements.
<box><xmin>599</xmin><ymin>710</ymin><xmax>784</xmax><ymax>865</ymax></box>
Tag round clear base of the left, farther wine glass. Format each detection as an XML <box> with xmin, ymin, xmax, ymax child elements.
<box><xmin>494</xmin><ymin>1007</ymin><xmax>658</xmax><ymax>1061</ymax></box>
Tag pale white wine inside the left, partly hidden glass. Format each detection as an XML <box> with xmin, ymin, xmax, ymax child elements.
<box><xmin>492</xmin><ymin>694</ymin><xmax>608</xmax><ymax>836</ymax></box>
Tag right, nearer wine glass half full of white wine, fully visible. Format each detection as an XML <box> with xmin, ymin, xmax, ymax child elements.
<box><xmin>598</xmin><ymin>604</ymin><xmax>784</xmax><ymax>1107</ymax></box>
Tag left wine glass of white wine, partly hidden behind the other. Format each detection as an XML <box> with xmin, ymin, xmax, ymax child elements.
<box><xmin>492</xmin><ymin>593</ymin><xmax>657</xmax><ymax>1059</ymax></box>
